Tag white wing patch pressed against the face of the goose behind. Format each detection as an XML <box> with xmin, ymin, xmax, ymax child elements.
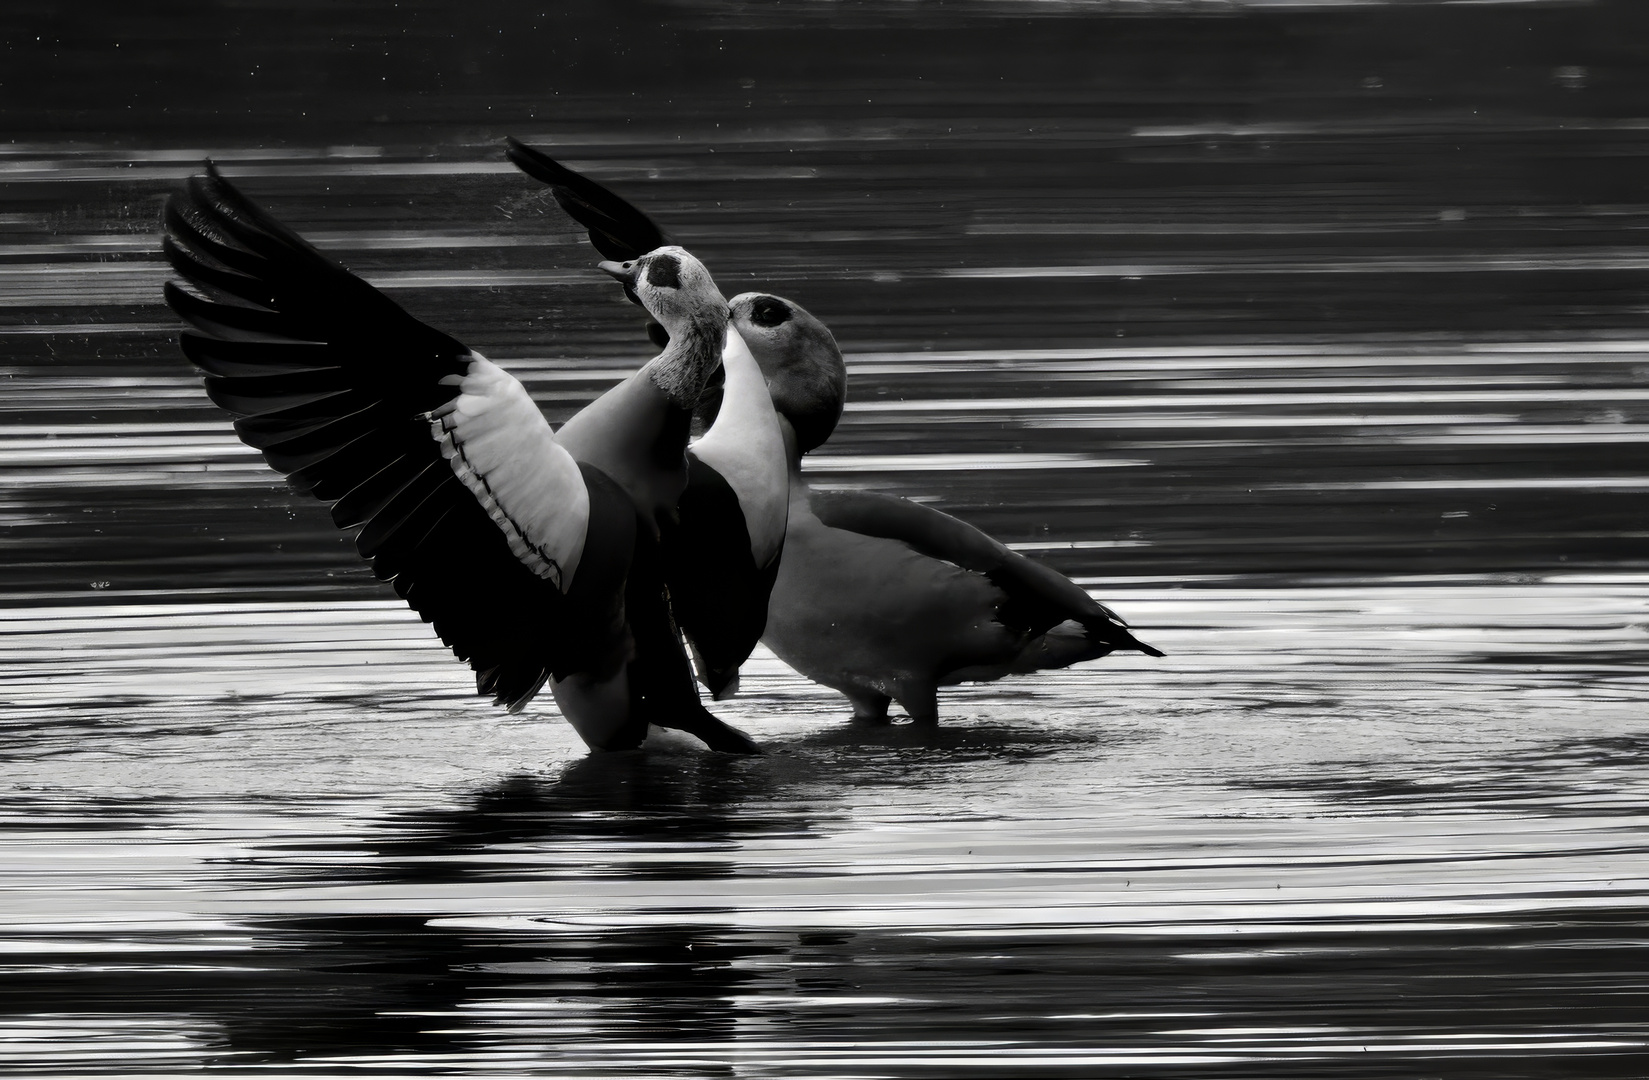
<box><xmin>693</xmin><ymin>326</ymin><xmax>790</xmax><ymax>567</ymax></box>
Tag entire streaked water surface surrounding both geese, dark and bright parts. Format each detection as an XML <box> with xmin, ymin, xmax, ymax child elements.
<box><xmin>0</xmin><ymin>0</ymin><xmax>1649</xmax><ymax>1077</ymax></box>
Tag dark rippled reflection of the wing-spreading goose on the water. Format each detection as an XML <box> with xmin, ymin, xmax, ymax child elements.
<box><xmin>170</xmin><ymin>761</ymin><xmax>837</xmax><ymax>1075</ymax></box>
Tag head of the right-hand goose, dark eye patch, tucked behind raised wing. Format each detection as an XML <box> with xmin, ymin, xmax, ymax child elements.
<box><xmin>729</xmin><ymin>292</ymin><xmax>848</xmax><ymax>453</ymax></box>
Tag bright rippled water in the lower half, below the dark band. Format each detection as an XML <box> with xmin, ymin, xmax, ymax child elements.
<box><xmin>0</xmin><ymin>586</ymin><xmax>1649</xmax><ymax>1077</ymax></box>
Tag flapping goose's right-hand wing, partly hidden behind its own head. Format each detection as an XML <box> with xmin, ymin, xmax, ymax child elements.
<box><xmin>506</xmin><ymin>139</ymin><xmax>790</xmax><ymax>699</ymax></box>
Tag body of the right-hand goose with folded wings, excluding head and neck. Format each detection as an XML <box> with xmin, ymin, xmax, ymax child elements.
<box><xmin>762</xmin><ymin>438</ymin><xmax>1161</xmax><ymax>724</ymax></box>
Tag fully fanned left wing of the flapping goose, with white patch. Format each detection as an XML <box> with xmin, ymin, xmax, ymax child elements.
<box><xmin>165</xmin><ymin>167</ymin><xmax>633</xmax><ymax>709</ymax></box>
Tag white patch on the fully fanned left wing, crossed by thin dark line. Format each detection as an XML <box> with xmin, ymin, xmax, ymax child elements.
<box><xmin>429</xmin><ymin>353</ymin><xmax>590</xmax><ymax>592</ymax></box>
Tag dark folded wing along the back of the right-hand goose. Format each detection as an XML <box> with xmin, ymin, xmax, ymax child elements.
<box><xmin>810</xmin><ymin>491</ymin><xmax>1163</xmax><ymax>656</ymax></box>
